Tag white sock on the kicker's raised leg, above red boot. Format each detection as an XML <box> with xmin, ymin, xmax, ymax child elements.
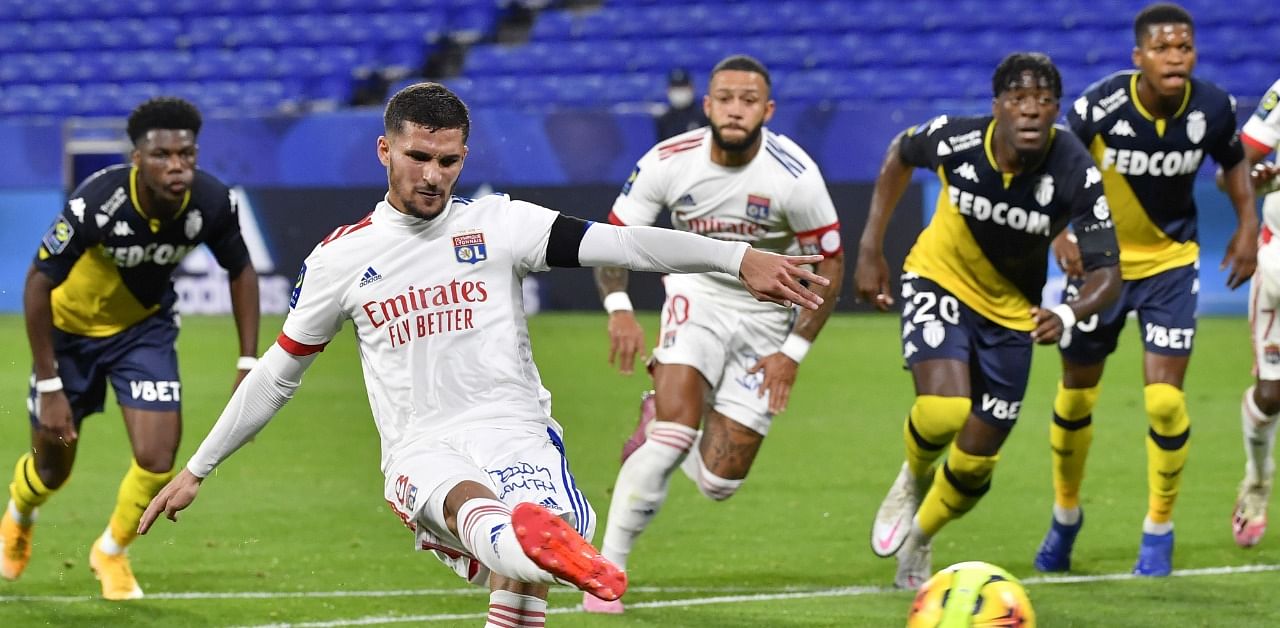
<box><xmin>458</xmin><ymin>498</ymin><xmax>557</xmax><ymax>585</ymax></box>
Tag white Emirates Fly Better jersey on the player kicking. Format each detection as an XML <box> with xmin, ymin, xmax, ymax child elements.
<box><xmin>285</xmin><ymin>194</ymin><xmax>558</xmax><ymax>471</ymax></box>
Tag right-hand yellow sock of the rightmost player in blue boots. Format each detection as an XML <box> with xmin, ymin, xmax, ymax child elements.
<box><xmin>1143</xmin><ymin>384</ymin><xmax>1192</xmax><ymax>524</ymax></box>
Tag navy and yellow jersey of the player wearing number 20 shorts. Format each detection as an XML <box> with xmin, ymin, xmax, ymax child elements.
<box><xmin>899</xmin><ymin>115</ymin><xmax>1119</xmax><ymax>331</ymax></box>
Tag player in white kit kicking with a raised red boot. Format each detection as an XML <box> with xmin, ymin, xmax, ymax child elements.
<box><xmin>138</xmin><ymin>83</ymin><xmax>827</xmax><ymax>627</ymax></box>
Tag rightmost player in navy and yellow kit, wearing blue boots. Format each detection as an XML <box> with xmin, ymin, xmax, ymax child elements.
<box><xmin>1036</xmin><ymin>4</ymin><xmax>1258</xmax><ymax>576</ymax></box>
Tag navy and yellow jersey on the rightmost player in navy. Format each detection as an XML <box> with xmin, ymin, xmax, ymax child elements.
<box><xmin>1066</xmin><ymin>70</ymin><xmax>1244</xmax><ymax>279</ymax></box>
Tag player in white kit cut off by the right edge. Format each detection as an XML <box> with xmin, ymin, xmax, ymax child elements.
<box><xmin>1231</xmin><ymin>81</ymin><xmax>1280</xmax><ymax>547</ymax></box>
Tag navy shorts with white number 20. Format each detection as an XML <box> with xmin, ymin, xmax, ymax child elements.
<box><xmin>902</xmin><ymin>274</ymin><xmax>1032</xmax><ymax>430</ymax></box>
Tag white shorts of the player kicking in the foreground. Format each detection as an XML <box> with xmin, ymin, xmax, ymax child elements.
<box><xmin>384</xmin><ymin>422</ymin><xmax>595</xmax><ymax>585</ymax></box>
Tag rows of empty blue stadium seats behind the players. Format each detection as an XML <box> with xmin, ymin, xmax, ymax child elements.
<box><xmin>0</xmin><ymin>0</ymin><xmax>1280</xmax><ymax>119</ymax></box>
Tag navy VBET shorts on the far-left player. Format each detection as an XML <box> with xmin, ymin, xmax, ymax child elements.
<box><xmin>27</xmin><ymin>312</ymin><xmax>182</xmax><ymax>426</ymax></box>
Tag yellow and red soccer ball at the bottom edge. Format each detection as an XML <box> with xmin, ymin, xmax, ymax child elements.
<box><xmin>906</xmin><ymin>560</ymin><xmax>1036</xmax><ymax>628</ymax></box>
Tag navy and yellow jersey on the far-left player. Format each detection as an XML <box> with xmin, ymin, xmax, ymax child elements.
<box><xmin>35</xmin><ymin>165</ymin><xmax>250</xmax><ymax>338</ymax></box>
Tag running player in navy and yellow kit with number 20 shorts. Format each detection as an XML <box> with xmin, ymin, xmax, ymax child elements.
<box><xmin>855</xmin><ymin>52</ymin><xmax>1120</xmax><ymax>588</ymax></box>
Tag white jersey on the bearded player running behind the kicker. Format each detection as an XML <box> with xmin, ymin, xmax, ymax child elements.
<box><xmin>609</xmin><ymin>127</ymin><xmax>841</xmax><ymax>303</ymax></box>
